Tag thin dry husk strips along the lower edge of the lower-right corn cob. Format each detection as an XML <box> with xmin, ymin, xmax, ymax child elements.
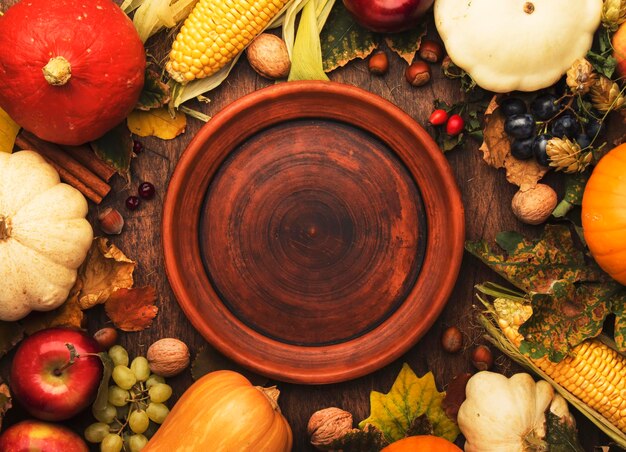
<box><xmin>476</xmin><ymin>283</ymin><xmax>626</xmax><ymax>448</ymax></box>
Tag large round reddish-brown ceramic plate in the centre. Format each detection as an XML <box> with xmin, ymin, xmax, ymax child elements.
<box><xmin>163</xmin><ymin>82</ymin><xmax>464</xmax><ymax>384</ymax></box>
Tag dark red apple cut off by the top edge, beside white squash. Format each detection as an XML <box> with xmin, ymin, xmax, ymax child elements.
<box><xmin>343</xmin><ymin>0</ymin><xmax>433</xmax><ymax>33</ymax></box>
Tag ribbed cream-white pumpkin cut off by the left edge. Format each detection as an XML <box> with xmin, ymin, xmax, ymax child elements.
<box><xmin>0</xmin><ymin>151</ymin><xmax>93</xmax><ymax>321</ymax></box>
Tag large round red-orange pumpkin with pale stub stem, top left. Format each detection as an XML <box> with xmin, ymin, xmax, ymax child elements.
<box><xmin>0</xmin><ymin>0</ymin><xmax>146</xmax><ymax>144</ymax></box>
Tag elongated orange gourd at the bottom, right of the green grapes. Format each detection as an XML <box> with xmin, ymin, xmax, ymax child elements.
<box><xmin>142</xmin><ymin>370</ymin><xmax>293</xmax><ymax>452</ymax></box>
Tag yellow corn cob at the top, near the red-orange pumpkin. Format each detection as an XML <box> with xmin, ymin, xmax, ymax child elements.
<box><xmin>165</xmin><ymin>0</ymin><xmax>288</xmax><ymax>84</ymax></box>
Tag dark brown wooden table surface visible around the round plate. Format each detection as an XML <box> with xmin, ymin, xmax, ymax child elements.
<box><xmin>0</xmin><ymin>0</ymin><xmax>608</xmax><ymax>451</ymax></box>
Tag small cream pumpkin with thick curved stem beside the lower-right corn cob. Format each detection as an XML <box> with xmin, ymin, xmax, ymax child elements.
<box><xmin>457</xmin><ymin>371</ymin><xmax>575</xmax><ymax>452</ymax></box>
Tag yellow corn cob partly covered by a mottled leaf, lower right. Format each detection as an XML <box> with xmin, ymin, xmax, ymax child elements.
<box><xmin>493</xmin><ymin>298</ymin><xmax>626</xmax><ymax>433</ymax></box>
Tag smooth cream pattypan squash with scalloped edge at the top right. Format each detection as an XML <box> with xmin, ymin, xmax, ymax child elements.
<box><xmin>434</xmin><ymin>0</ymin><xmax>602</xmax><ymax>93</ymax></box>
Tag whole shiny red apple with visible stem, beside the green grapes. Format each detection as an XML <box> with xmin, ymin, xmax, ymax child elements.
<box><xmin>10</xmin><ymin>328</ymin><xmax>102</xmax><ymax>421</ymax></box>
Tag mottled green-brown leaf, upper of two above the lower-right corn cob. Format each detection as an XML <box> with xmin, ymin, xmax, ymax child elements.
<box><xmin>465</xmin><ymin>225</ymin><xmax>609</xmax><ymax>293</ymax></box>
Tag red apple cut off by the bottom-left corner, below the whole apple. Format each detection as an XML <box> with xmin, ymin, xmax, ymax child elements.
<box><xmin>0</xmin><ymin>420</ymin><xmax>89</xmax><ymax>452</ymax></box>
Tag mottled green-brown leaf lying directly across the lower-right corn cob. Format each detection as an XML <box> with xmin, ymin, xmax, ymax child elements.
<box><xmin>519</xmin><ymin>280</ymin><xmax>620</xmax><ymax>362</ymax></box>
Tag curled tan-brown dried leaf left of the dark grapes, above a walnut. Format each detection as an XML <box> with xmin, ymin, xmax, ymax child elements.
<box><xmin>480</xmin><ymin>96</ymin><xmax>549</xmax><ymax>190</ymax></box>
